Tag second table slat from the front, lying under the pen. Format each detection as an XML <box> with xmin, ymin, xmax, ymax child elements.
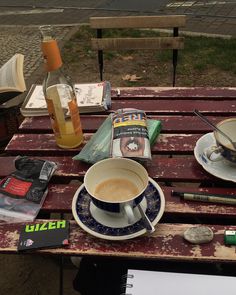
<box><xmin>41</xmin><ymin>184</ymin><xmax>236</xmax><ymax>222</ymax></box>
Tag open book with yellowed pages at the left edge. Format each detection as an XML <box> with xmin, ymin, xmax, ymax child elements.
<box><xmin>0</xmin><ymin>53</ymin><xmax>26</xmax><ymax>104</ymax></box>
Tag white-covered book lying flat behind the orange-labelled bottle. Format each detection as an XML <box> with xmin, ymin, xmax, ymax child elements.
<box><xmin>20</xmin><ymin>81</ymin><xmax>111</xmax><ymax>117</ymax></box>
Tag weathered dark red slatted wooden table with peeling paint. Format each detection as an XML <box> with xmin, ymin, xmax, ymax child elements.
<box><xmin>0</xmin><ymin>87</ymin><xmax>236</xmax><ymax>268</ymax></box>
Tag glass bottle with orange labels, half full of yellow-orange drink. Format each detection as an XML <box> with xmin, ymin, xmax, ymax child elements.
<box><xmin>40</xmin><ymin>26</ymin><xmax>83</xmax><ymax>148</ymax></box>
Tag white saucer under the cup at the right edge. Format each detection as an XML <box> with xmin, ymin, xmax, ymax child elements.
<box><xmin>194</xmin><ymin>132</ymin><xmax>236</xmax><ymax>182</ymax></box>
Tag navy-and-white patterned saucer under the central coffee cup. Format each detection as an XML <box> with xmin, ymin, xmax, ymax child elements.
<box><xmin>72</xmin><ymin>178</ymin><xmax>165</xmax><ymax>240</ymax></box>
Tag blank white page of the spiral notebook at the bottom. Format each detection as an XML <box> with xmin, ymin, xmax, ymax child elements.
<box><xmin>125</xmin><ymin>269</ymin><xmax>235</xmax><ymax>295</ymax></box>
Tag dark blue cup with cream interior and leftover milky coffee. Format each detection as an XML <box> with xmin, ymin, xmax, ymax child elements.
<box><xmin>84</xmin><ymin>158</ymin><xmax>148</xmax><ymax>224</ymax></box>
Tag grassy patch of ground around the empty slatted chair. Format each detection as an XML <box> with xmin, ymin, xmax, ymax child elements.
<box><xmin>62</xmin><ymin>26</ymin><xmax>236</xmax><ymax>86</ymax></box>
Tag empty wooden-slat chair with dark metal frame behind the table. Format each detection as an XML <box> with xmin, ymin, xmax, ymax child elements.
<box><xmin>90</xmin><ymin>15</ymin><xmax>186</xmax><ymax>86</ymax></box>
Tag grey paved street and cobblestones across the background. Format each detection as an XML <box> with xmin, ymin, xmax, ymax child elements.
<box><xmin>0</xmin><ymin>0</ymin><xmax>236</xmax><ymax>85</ymax></box>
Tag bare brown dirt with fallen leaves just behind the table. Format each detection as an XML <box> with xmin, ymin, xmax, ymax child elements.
<box><xmin>65</xmin><ymin>53</ymin><xmax>236</xmax><ymax>87</ymax></box>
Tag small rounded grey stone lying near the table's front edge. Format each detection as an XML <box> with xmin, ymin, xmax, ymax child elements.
<box><xmin>184</xmin><ymin>226</ymin><xmax>214</xmax><ymax>244</ymax></box>
